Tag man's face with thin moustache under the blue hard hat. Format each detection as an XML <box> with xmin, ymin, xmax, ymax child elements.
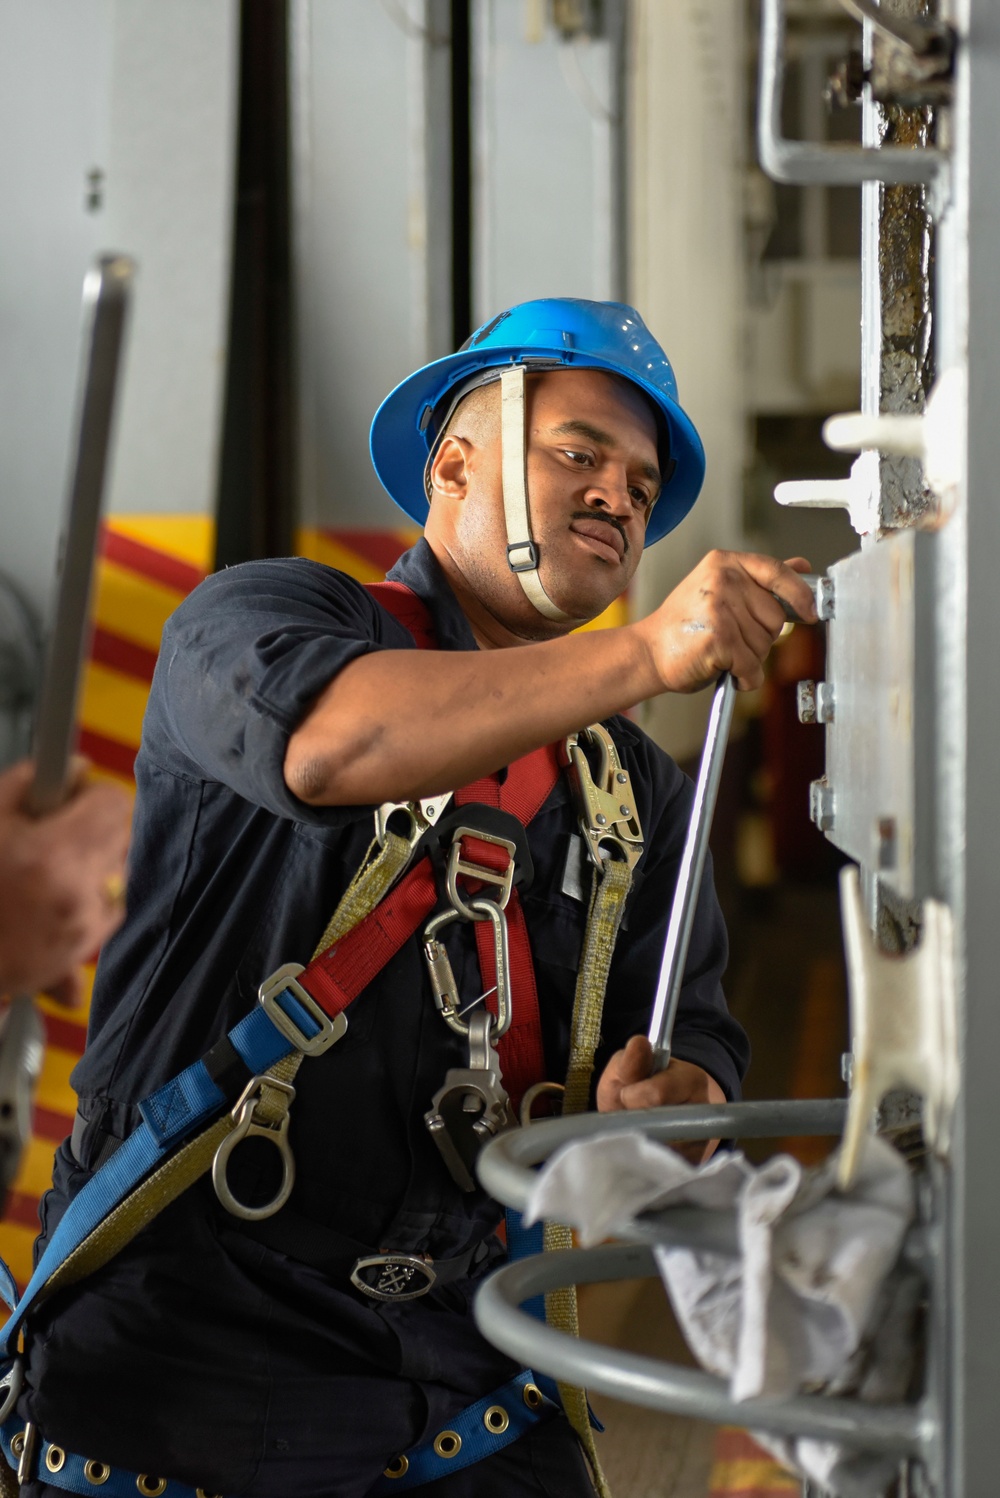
<box><xmin>428</xmin><ymin>370</ymin><xmax>660</xmax><ymax>638</ymax></box>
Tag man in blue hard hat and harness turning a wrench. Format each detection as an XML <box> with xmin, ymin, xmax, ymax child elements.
<box><xmin>13</xmin><ymin>300</ymin><xmax>814</xmax><ymax>1498</ymax></box>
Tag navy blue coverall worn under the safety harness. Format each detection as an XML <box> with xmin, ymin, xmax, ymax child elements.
<box><xmin>21</xmin><ymin>541</ymin><xmax>749</xmax><ymax>1498</ymax></box>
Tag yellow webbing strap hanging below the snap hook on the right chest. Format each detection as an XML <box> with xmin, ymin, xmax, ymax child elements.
<box><xmin>545</xmin><ymin>860</ymin><xmax>632</xmax><ymax>1498</ymax></box>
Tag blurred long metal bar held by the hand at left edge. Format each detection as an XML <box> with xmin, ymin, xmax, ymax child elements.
<box><xmin>0</xmin><ymin>255</ymin><xmax>135</xmax><ymax>1212</ymax></box>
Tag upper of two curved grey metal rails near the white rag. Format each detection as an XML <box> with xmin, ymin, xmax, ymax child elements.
<box><xmin>478</xmin><ymin>1098</ymin><xmax>847</xmax><ymax>1212</ymax></box>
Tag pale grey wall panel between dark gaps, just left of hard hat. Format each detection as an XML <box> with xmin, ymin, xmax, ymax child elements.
<box><xmin>292</xmin><ymin>0</ymin><xmax>451</xmax><ymax>529</ymax></box>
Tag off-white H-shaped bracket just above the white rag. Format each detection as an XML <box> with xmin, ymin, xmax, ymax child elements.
<box><xmin>840</xmin><ymin>866</ymin><xmax>958</xmax><ymax>1188</ymax></box>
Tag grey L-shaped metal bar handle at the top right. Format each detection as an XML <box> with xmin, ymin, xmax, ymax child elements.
<box><xmin>757</xmin><ymin>0</ymin><xmax>949</xmax><ymax>196</ymax></box>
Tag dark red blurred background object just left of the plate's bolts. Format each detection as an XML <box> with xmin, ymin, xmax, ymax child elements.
<box><xmin>760</xmin><ymin>625</ymin><xmax>843</xmax><ymax>881</ymax></box>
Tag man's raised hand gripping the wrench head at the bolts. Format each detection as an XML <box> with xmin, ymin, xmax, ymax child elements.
<box><xmin>635</xmin><ymin>551</ymin><xmax>816</xmax><ymax>692</ymax></box>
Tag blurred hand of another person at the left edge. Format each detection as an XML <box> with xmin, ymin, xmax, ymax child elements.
<box><xmin>0</xmin><ymin>761</ymin><xmax>132</xmax><ymax>1005</ymax></box>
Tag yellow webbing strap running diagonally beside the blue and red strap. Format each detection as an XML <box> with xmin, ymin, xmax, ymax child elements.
<box><xmin>26</xmin><ymin>833</ymin><xmax>412</xmax><ymax>1312</ymax></box>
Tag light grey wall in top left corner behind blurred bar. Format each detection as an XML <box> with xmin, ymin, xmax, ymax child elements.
<box><xmin>0</xmin><ymin>0</ymin><xmax>238</xmax><ymax>599</ymax></box>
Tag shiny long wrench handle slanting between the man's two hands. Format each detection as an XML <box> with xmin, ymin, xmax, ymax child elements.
<box><xmin>650</xmin><ymin>673</ymin><xmax>737</xmax><ymax>1071</ymax></box>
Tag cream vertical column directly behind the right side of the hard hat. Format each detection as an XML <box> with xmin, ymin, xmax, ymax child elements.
<box><xmin>627</xmin><ymin>0</ymin><xmax>746</xmax><ymax>759</ymax></box>
